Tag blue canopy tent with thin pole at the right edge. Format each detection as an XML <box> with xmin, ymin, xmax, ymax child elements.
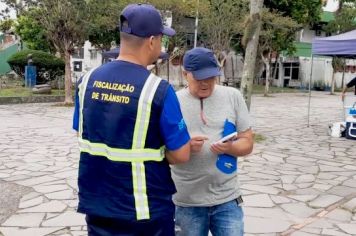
<box><xmin>308</xmin><ymin>30</ymin><xmax>356</xmax><ymax>127</ymax></box>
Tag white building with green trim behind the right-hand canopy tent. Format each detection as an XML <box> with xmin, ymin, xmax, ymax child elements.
<box><xmin>272</xmin><ymin>0</ymin><xmax>356</xmax><ymax>89</ymax></box>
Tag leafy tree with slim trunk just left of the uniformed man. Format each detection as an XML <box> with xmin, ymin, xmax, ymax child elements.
<box><xmin>6</xmin><ymin>0</ymin><xmax>88</xmax><ymax>104</ymax></box>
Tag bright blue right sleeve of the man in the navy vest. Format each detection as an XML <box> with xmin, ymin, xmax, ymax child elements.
<box><xmin>160</xmin><ymin>86</ymin><xmax>190</xmax><ymax>151</ymax></box>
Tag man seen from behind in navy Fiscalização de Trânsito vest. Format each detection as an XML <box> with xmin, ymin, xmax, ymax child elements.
<box><xmin>73</xmin><ymin>4</ymin><xmax>190</xmax><ymax>236</ymax></box>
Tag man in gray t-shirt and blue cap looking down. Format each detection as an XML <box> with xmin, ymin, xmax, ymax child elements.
<box><xmin>172</xmin><ymin>47</ymin><xmax>253</xmax><ymax>236</ymax></box>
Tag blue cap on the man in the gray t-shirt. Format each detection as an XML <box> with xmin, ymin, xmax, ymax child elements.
<box><xmin>183</xmin><ymin>47</ymin><xmax>221</xmax><ymax>80</ymax></box>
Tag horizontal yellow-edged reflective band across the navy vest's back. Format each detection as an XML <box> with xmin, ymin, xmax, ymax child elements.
<box><xmin>79</xmin><ymin>138</ymin><xmax>164</xmax><ymax>162</ymax></box>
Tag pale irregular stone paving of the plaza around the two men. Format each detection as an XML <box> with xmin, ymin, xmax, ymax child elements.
<box><xmin>0</xmin><ymin>93</ymin><xmax>356</xmax><ymax>236</ymax></box>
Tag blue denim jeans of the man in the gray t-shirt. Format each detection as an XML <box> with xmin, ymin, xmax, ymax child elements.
<box><xmin>176</xmin><ymin>200</ymin><xmax>244</xmax><ymax>236</ymax></box>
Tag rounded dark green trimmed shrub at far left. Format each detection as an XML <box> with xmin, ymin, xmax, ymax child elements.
<box><xmin>7</xmin><ymin>50</ymin><xmax>64</xmax><ymax>84</ymax></box>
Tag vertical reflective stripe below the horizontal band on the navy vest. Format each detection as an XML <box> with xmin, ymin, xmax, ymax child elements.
<box><xmin>132</xmin><ymin>162</ymin><xmax>150</xmax><ymax>220</ymax></box>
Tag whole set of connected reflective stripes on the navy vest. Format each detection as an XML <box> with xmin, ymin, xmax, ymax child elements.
<box><xmin>79</xmin><ymin>71</ymin><xmax>164</xmax><ymax>220</ymax></box>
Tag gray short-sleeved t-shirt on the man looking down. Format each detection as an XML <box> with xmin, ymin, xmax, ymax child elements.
<box><xmin>171</xmin><ymin>85</ymin><xmax>250</xmax><ymax>206</ymax></box>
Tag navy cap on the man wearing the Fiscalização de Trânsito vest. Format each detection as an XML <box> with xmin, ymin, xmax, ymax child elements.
<box><xmin>120</xmin><ymin>4</ymin><xmax>176</xmax><ymax>38</ymax></box>
